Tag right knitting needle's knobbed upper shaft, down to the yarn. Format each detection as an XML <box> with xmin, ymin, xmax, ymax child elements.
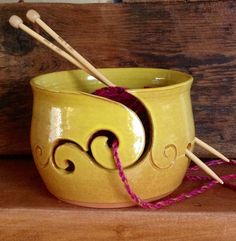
<box><xmin>26</xmin><ymin>9</ymin><xmax>115</xmax><ymax>86</ymax></box>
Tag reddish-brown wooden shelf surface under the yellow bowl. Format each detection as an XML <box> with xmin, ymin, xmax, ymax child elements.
<box><xmin>0</xmin><ymin>159</ymin><xmax>236</xmax><ymax>241</ymax></box>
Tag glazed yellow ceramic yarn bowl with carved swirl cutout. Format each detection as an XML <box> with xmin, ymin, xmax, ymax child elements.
<box><xmin>31</xmin><ymin>68</ymin><xmax>195</xmax><ymax>208</ymax></box>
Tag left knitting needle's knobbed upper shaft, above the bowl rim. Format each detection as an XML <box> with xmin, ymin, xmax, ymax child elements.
<box><xmin>9</xmin><ymin>15</ymin><xmax>87</xmax><ymax>69</ymax></box>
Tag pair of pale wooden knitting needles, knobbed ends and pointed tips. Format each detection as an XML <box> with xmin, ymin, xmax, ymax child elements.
<box><xmin>9</xmin><ymin>9</ymin><xmax>229</xmax><ymax>184</ymax></box>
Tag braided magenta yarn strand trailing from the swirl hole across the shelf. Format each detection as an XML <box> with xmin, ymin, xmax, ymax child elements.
<box><xmin>112</xmin><ymin>140</ymin><xmax>236</xmax><ymax>209</ymax></box>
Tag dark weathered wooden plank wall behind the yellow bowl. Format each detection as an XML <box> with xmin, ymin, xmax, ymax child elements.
<box><xmin>0</xmin><ymin>0</ymin><xmax>236</xmax><ymax>157</ymax></box>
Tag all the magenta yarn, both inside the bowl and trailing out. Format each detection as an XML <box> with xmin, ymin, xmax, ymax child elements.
<box><xmin>93</xmin><ymin>87</ymin><xmax>236</xmax><ymax>209</ymax></box>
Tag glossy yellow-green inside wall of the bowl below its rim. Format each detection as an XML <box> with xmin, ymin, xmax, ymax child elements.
<box><xmin>31</xmin><ymin>68</ymin><xmax>192</xmax><ymax>93</ymax></box>
